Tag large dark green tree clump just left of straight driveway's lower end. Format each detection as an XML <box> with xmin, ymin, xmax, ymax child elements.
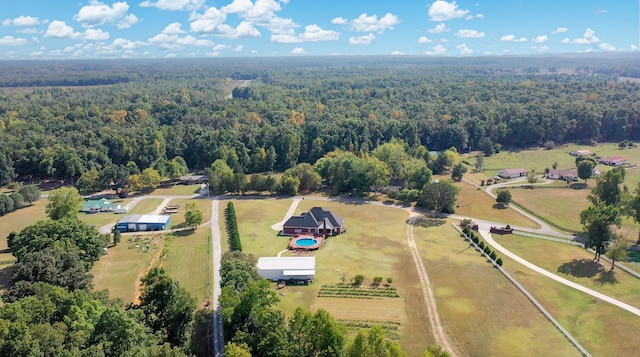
<box><xmin>140</xmin><ymin>268</ymin><xmax>196</xmax><ymax>347</ymax></box>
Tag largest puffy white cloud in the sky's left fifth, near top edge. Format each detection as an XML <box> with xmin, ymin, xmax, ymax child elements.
<box><xmin>73</xmin><ymin>0</ymin><xmax>139</xmax><ymax>28</ymax></box>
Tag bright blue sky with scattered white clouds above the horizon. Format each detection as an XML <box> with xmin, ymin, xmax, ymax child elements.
<box><xmin>0</xmin><ymin>0</ymin><xmax>639</xmax><ymax>60</ymax></box>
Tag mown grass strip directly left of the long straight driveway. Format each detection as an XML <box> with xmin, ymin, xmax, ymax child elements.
<box><xmin>160</xmin><ymin>228</ymin><xmax>213</xmax><ymax>306</ymax></box>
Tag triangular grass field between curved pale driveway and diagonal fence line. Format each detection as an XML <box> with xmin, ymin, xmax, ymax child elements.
<box><xmin>494</xmin><ymin>236</ymin><xmax>640</xmax><ymax>357</ymax></box>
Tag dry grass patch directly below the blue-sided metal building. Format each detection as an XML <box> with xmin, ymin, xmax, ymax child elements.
<box><xmin>89</xmin><ymin>234</ymin><xmax>164</xmax><ymax>304</ymax></box>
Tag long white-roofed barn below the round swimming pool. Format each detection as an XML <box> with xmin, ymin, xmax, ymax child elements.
<box><xmin>257</xmin><ymin>257</ymin><xmax>316</xmax><ymax>281</ymax></box>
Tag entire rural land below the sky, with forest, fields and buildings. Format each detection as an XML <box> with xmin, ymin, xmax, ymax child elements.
<box><xmin>0</xmin><ymin>54</ymin><xmax>640</xmax><ymax>357</ymax></box>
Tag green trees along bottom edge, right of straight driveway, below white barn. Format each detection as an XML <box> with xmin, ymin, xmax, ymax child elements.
<box><xmin>220</xmin><ymin>252</ymin><xmax>448</xmax><ymax>357</ymax></box>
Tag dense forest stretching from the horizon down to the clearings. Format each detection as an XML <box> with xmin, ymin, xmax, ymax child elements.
<box><xmin>0</xmin><ymin>55</ymin><xmax>640</xmax><ymax>188</ymax></box>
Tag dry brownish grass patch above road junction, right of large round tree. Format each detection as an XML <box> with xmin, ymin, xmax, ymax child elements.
<box><xmin>455</xmin><ymin>181</ymin><xmax>540</xmax><ymax>228</ymax></box>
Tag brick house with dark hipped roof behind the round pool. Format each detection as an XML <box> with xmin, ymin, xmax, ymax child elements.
<box><xmin>282</xmin><ymin>207</ymin><xmax>344</xmax><ymax>236</ymax></box>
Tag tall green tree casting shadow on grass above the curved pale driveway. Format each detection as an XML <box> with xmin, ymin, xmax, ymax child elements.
<box><xmin>580</xmin><ymin>202</ymin><xmax>621</xmax><ymax>261</ymax></box>
